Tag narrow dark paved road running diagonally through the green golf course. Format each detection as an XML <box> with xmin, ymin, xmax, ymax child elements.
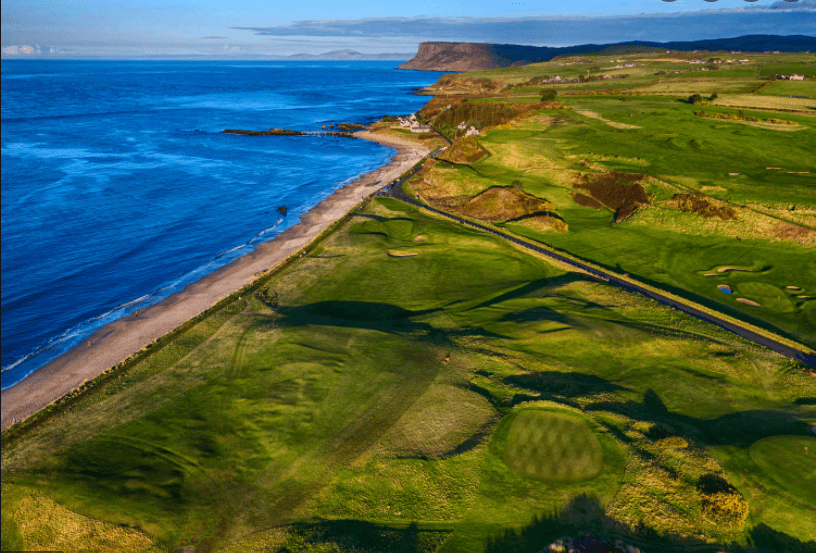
<box><xmin>377</xmin><ymin>168</ymin><xmax>816</xmax><ymax>368</ymax></box>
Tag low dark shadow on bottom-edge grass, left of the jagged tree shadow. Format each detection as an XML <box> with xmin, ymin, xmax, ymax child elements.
<box><xmin>277</xmin><ymin>520</ymin><xmax>450</xmax><ymax>553</ymax></box>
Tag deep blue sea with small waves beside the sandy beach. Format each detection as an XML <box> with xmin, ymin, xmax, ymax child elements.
<box><xmin>0</xmin><ymin>60</ymin><xmax>440</xmax><ymax>388</ymax></box>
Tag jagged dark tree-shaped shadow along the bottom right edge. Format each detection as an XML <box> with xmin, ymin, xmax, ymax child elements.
<box><xmin>484</xmin><ymin>495</ymin><xmax>816</xmax><ymax>553</ymax></box>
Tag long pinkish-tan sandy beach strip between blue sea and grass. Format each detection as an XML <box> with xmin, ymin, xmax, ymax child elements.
<box><xmin>0</xmin><ymin>131</ymin><xmax>429</xmax><ymax>432</ymax></box>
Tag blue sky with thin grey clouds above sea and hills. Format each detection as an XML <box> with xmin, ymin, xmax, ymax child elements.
<box><xmin>0</xmin><ymin>0</ymin><xmax>816</xmax><ymax>59</ymax></box>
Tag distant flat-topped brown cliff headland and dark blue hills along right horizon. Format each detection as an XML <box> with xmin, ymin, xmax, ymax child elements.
<box><xmin>399</xmin><ymin>35</ymin><xmax>816</xmax><ymax>71</ymax></box>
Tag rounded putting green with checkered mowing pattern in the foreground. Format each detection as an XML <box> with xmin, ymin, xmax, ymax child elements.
<box><xmin>503</xmin><ymin>410</ymin><xmax>603</xmax><ymax>482</ymax></box>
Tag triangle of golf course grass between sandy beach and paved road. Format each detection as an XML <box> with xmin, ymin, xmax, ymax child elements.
<box><xmin>2</xmin><ymin>195</ymin><xmax>816</xmax><ymax>552</ymax></box>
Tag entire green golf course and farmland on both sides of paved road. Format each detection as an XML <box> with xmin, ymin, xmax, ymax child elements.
<box><xmin>2</xmin><ymin>49</ymin><xmax>816</xmax><ymax>553</ymax></box>
